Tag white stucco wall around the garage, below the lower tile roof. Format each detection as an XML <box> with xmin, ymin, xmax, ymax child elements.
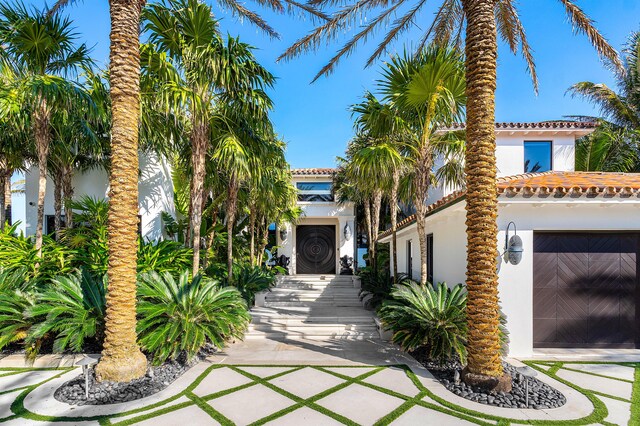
<box><xmin>383</xmin><ymin>199</ymin><xmax>640</xmax><ymax>357</ymax></box>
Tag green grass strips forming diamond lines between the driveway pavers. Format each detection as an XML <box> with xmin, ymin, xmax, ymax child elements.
<box><xmin>0</xmin><ymin>361</ymin><xmax>640</xmax><ymax>426</ymax></box>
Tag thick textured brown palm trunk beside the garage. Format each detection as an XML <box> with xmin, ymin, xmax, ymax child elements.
<box><xmin>463</xmin><ymin>0</ymin><xmax>511</xmax><ymax>391</ymax></box>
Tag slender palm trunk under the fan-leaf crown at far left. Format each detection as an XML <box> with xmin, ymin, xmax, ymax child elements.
<box><xmin>33</xmin><ymin>98</ymin><xmax>51</xmax><ymax>257</ymax></box>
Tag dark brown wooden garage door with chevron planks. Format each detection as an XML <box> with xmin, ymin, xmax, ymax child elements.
<box><xmin>533</xmin><ymin>233</ymin><xmax>640</xmax><ymax>348</ymax></box>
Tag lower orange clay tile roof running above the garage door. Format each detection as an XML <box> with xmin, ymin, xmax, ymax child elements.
<box><xmin>379</xmin><ymin>172</ymin><xmax>640</xmax><ymax>238</ymax></box>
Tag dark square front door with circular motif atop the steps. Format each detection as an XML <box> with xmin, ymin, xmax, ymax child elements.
<box><xmin>296</xmin><ymin>225</ymin><xmax>336</xmax><ymax>274</ymax></box>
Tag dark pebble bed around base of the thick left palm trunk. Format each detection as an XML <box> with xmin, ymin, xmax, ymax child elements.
<box><xmin>53</xmin><ymin>354</ymin><xmax>212</xmax><ymax>405</ymax></box>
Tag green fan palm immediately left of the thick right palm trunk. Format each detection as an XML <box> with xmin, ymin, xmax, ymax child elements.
<box><xmin>379</xmin><ymin>47</ymin><xmax>466</xmax><ymax>284</ymax></box>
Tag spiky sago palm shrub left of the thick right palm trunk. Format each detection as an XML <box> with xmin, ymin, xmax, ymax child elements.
<box><xmin>378</xmin><ymin>282</ymin><xmax>467</xmax><ymax>363</ymax></box>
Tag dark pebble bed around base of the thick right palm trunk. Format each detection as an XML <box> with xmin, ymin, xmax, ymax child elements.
<box><xmin>412</xmin><ymin>353</ymin><xmax>567</xmax><ymax>410</ymax></box>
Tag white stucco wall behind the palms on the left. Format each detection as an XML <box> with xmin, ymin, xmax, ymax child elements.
<box><xmin>25</xmin><ymin>155</ymin><xmax>175</xmax><ymax>240</ymax></box>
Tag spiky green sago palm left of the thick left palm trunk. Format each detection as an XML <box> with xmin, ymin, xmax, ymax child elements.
<box><xmin>25</xmin><ymin>270</ymin><xmax>107</xmax><ymax>353</ymax></box>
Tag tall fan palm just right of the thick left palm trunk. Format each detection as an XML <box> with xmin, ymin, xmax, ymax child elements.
<box><xmin>144</xmin><ymin>0</ymin><xmax>273</xmax><ymax>275</ymax></box>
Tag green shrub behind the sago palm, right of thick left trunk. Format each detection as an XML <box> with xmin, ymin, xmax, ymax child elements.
<box><xmin>138</xmin><ymin>240</ymin><xmax>193</xmax><ymax>275</ymax></box>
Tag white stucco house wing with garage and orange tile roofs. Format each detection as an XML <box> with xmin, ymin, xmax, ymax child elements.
<box><xmin>381</xmin><ymin>122</ymin><xmax>640</xmax><ymax>357</ymax></box>
